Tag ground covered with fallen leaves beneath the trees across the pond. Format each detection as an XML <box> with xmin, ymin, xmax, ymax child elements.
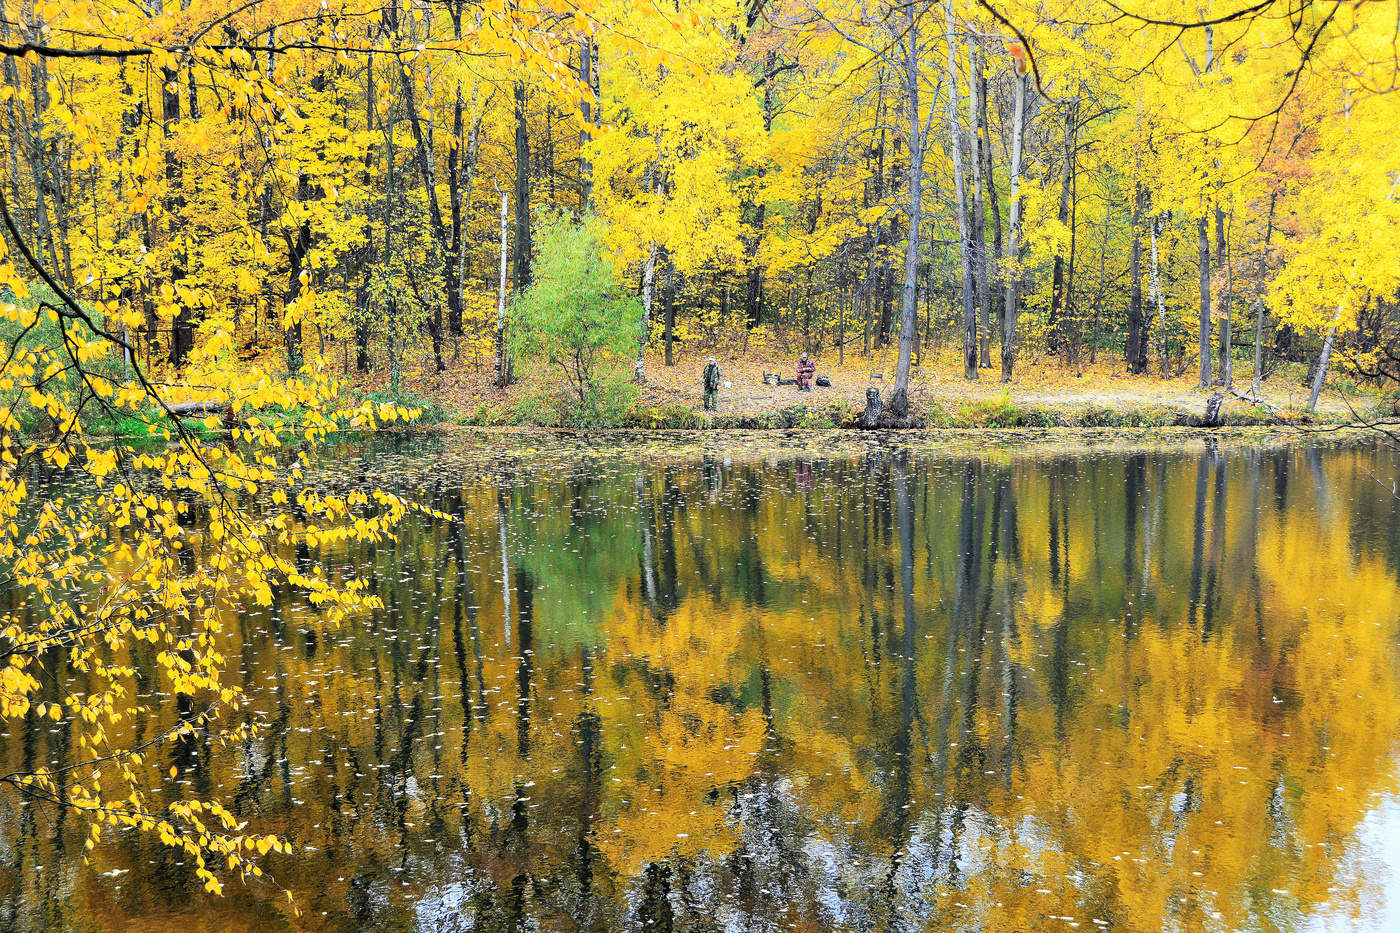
<box><xmin>361</xmin><ymin>341</ymin><xmax>1385</xmax><ymax>427</ymax></box>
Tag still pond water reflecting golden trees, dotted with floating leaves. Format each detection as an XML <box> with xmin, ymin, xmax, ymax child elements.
<box><xmin>0</xmin><ymin>434</ymin><xmax>1400</xmax><ymax>930</ymax></box>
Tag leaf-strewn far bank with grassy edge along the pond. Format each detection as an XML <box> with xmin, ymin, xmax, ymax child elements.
<box><xmin>386</xmin><ymin>353</ymin><xmax>1394</xmax><ymax>431</ymax></box>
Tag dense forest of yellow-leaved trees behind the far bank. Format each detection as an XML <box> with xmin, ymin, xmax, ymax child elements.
<box><xmin>0</xmin><ymin>0</ymin><xmax>1400</xmax><ymax>419</ymax></box>
